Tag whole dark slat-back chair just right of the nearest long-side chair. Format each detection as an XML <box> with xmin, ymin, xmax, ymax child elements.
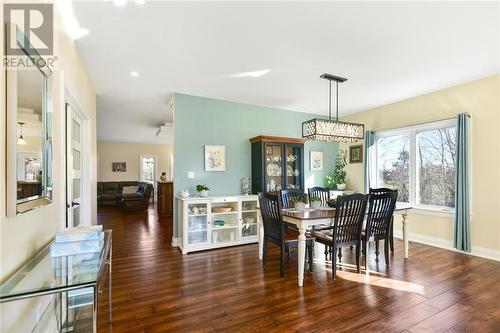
<box><xmin>361</xmin><ymin>192</ymin><xmax>397</xmax><ymax>266</ymax></box>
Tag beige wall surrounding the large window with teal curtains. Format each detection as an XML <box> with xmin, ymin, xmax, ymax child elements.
<box><xmin>342</xmin><ymin>75</ymin><xmax>500</xmax><ymax>254</ymax></box>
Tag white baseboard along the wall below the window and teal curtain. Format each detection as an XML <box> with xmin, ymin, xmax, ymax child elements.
<box><xmin>394</xmin><ymin>230</ymin><xmax>500</xmax><ymax>261</ymax></box>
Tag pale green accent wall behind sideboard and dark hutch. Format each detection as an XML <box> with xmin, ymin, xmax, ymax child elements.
<box><xmin>174</xmin><ymin>94</ymin><xmax>338</xmax><ymax>235</ymax></box>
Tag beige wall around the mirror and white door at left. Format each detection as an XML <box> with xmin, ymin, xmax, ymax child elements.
<box><xmin>0</xmin><ymin>9</ymin><xmax>97</xmax><ymax>332</ymax></box>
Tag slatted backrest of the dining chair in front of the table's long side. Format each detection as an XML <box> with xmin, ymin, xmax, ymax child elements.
<box><xmin>333</xmin><ymin>193</ymin><xmax>368</xmax><ymax>244</ymax></box>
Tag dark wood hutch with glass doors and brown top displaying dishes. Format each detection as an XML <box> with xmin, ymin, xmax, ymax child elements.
<box><xmin>250</xmin><ymin>135</ymin><xmax>305</xmax><ymax>194</ymax></box>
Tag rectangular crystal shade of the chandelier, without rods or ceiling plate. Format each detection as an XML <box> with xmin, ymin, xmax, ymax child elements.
<box><xmin>302</xmin><ymin>118</ymin><xmax>365</xmax><ymax>143</ymax></box>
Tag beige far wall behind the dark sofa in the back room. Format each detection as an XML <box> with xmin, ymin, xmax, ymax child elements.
<box><xmin>97</xmin><ymin>141</ymin><xmax>173</xmax><ymax>181</ymax></box>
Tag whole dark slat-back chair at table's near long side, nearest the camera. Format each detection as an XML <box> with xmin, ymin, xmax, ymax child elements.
<box><xmin>311</xmin><ymin>193</ymin><xmax>368</xmax><ymax>279</ymax></box>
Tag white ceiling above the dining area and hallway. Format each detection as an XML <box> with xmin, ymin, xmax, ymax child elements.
<box><xmin>74</xmin><ymin>1</ymin><xmax>500</xmax><ymax>143</ymax></box>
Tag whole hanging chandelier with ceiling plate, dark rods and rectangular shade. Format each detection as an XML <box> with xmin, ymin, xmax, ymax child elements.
<box><xmin>302</xmin><ymin>73</ymin><xmax>365</xmax><ymax>143</ymax></box>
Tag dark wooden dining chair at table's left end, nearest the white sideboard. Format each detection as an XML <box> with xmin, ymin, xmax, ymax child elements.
<box><xmin>259</xmin><ymin>193</ymin><xmax>314</xmax><ymax>278</ymax></box>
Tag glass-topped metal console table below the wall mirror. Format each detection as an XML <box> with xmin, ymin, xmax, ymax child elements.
<box><xmin>0</xmin><ymin>230</ymin><xmax>112</xmax><ymax>332</ymax></box>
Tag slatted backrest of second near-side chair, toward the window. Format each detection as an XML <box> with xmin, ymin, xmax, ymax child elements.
<box><xmin>366</xmin><ymin>191</ymin><xmax>397</xmax><ymax>238</ymax></box>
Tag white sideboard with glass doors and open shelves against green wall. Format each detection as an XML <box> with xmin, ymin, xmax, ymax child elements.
<box><xmin>177</xmin><ymin>195</ymin><xmax>259</xmax><ymax>254</ymax></box>
